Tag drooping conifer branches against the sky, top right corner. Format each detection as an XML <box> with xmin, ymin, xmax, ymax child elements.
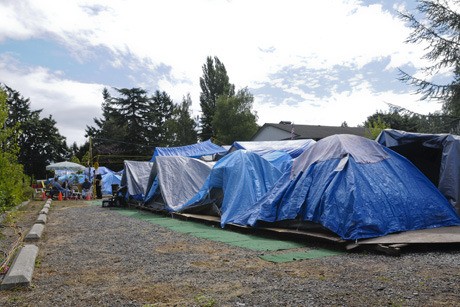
<box><xmin>400</xmin><ymin>0</ymin><xmax>460</xmax><ymax>125</ymax></box>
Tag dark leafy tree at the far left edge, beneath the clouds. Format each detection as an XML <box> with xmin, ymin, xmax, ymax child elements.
<box><xmin>3</xmin><ymin>85</ymin><xmax>69</xmax><ymax>179</ymax></box>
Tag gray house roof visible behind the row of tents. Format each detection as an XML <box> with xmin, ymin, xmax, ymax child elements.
<box><xmin>252</xmin><ymin>122</ymin><xmax>367</xmax><ymax>140</ymax></box>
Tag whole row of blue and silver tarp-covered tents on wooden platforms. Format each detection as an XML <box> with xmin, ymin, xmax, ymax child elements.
<box><xmin>120</xmin><ymin>130</ymin><xmax>460</xmax><ymax>240</ymax></box>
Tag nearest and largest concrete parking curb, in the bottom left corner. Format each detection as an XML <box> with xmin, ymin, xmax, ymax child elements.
<box><xmin>0</xmin><ymin>244</ymin><xmax>38</xmax><ymax>289</ymax></box>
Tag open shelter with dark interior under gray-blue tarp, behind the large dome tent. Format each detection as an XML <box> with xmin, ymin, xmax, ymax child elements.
<box><xmin>377</xmin><ymin>129</ymin><xmax>460</xmax><ymax>213</ymax></box>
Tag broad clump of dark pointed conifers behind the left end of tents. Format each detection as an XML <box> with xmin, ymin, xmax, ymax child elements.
<box><xmin>86</xmin><ymin>88</ymin><xmax>174</xmax><ymax>169</ymax></box>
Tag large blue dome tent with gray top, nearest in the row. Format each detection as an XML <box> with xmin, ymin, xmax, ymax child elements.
<box><xmin>248</xmin><ymin>135</ymin><xmax>460</xmax><ymax>240</ymax></box>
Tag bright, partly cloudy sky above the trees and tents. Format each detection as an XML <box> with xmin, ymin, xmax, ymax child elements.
<box><xmin>0</xmin><ymin>0</ymin><xmax>450</xmax><ymax>145</ymax></box>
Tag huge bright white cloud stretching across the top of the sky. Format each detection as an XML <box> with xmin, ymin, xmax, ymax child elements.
<box><xmin>0</xmin><ymin>0</ymin><xmax>428</xmax><ymax>86</ymax></box>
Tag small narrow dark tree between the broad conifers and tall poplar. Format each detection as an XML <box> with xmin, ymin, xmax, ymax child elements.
<box><xmin>166</xmin><ymin>94</ymin><xmax>198</xmax><ymax>146</ymax></box>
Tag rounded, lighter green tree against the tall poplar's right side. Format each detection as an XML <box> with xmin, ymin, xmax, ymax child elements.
<box><xmin>212</xmin><ymin>88</ymin><xmax>258</xmax><ymax>145</ymax></box>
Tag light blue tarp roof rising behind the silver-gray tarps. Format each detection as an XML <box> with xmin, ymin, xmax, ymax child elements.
<box><xmin>150</xmin><ymin>140</ymin><xmax>226</xmax><ymax>161</ymax></box>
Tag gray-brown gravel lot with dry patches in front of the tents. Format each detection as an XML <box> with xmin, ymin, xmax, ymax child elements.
<box><xmin>0</xmin><ymin>201</ymin><xmax>460</xmax><ymax>306</ymax></box>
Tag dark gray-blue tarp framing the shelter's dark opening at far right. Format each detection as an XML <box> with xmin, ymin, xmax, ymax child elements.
<box><xmin>377</xmin><ymin>129</ymin><xmax>460</xmax><ymax>213</ymax></box>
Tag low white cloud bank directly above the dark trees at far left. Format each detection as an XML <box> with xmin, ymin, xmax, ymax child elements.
<box><xmin>0</xmin><ymin>57</ymin><xmax>103</xmax><ymax>145</ymax></box>
